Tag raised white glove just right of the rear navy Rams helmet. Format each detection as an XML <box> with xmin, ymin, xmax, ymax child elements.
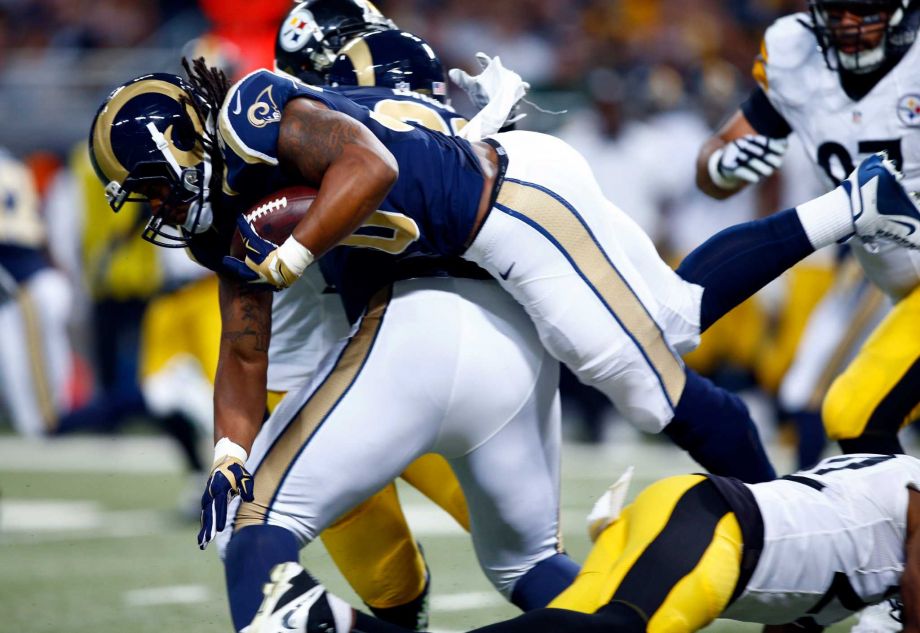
<box><xmin>448</xmin><ymin>53</ymin><xmax>530</xmax><ymax>141</ymax></box>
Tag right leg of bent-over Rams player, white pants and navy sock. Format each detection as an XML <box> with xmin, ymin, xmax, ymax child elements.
<box><xmin>437</xmin><ymin>280</ymin><xmax>577</xmax><ymax>609</ymax></box>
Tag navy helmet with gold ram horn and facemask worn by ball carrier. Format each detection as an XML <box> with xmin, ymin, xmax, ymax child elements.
<box><xmin>89</xmin><ymin>73</ymin><xmax>214</xmax><ymax>248</ymax></box>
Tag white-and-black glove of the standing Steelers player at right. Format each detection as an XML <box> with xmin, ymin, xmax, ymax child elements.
<box><xmin>709</xmin><ymin>134</ymin><xmax>789</xmax><ymax>190</ymax></box>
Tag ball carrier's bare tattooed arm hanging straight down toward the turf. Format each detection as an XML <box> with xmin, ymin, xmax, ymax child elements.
<box><xmin>214</xmin><ymin>277</ymin><xmax>272</xmax><ymax>452</ymax></box>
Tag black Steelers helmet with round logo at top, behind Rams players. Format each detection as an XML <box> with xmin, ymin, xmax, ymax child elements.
<box><xmin>275</xmin><ymin>0</ymin><xmax>396</xmax><ymax>85</ymax></box>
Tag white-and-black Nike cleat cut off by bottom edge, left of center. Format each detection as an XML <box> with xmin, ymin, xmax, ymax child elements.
<box><xmin>240</xmin><ymin>563</ymin><xmax>346</xmax><ymax>633</ymax></box>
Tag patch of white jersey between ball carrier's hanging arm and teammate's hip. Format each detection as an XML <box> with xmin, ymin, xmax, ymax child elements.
<box><xmin>268</xmin><ymin>266</ymin><xmax>351</xmax><ymax>391</ymax></box>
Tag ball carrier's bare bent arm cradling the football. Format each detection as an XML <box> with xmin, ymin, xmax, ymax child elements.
<box><xmin>278</xmin><ymin>99</ymin><xmax>399</xmax><ymax>258</ymax></box>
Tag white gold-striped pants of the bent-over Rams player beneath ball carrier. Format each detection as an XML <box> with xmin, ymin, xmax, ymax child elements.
<box><xmin>218</xmin><ymin>278</ymin><xmax>560</xmax><ymax>597</ymax></box>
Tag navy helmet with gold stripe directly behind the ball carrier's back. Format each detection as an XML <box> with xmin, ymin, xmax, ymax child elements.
<box><xmin>327</xmin><ymin>30</ymin><xmax>447</xmax><ymax>103</ymax></box>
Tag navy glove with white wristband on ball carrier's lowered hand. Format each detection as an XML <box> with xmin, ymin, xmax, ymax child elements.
<box><xmin>198</xmin><ymin>438</ymin><xmax>253</xmax><ymax>549</ymax></box>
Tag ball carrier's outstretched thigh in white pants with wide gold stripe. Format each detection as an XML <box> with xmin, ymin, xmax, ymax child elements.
<box><xmin>464</xmin><ymin>133</ymin><xmax>685</xmax><ymax>431</ymax></box>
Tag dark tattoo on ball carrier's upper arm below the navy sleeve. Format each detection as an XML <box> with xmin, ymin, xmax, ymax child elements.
<box><xmin>278</xmin><ymin>99</ymin><xmax>363</xmax><ymax>186</ymax></box>
